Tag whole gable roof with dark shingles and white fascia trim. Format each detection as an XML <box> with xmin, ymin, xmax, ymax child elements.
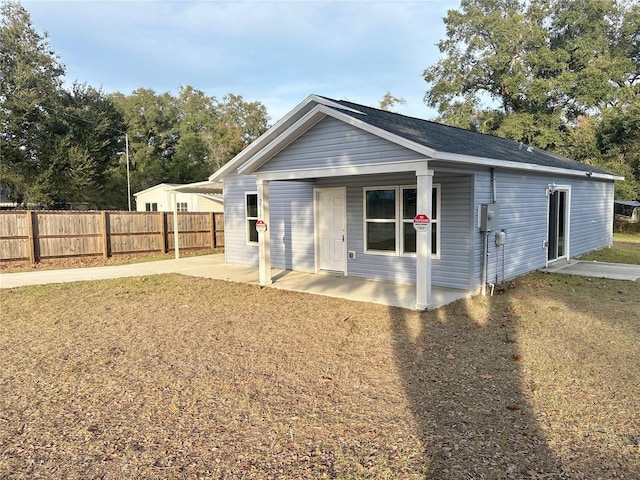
<box><xmin>210</xmin><ymin>95</ymin><xmax>622</xmax><ymax>180</ymax></box>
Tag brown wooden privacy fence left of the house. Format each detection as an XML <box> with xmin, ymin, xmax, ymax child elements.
<box><xmin>0</xmin><ymin>210</ymin><xmax>224</xmax><ymax>263</ymax></box>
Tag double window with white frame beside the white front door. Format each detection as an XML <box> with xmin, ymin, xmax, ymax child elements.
<box><xmin>364</xmin><ymin>185</ymin><xmax>440</xmax><ymax>257</ymax></box>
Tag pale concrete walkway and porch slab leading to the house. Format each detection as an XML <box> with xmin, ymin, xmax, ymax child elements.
<box><xmin>0</xmin><ymin>255</ymin><xmax>469</xmax><ymax>309</ymax></box>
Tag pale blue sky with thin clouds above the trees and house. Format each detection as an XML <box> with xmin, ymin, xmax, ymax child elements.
<box><xmin>21</xmin><ymin>0</ymin><xmax>460</xmax><ymax>123</ymax></box>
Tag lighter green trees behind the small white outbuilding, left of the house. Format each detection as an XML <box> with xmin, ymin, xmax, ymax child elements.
<box><xmin>110</xmin><ymin>86</ymin><xmax>268</xmax><ymax>195</ymax></box>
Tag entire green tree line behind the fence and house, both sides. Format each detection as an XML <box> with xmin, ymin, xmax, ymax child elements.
<box><xmin>0</xmin><ymin>0</ymin><xmax>640</xmax><ymax>209</ymax></box>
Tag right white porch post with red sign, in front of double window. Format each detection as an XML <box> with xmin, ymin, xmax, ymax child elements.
<box><xmin>416</xmin><ymin>169</ymin><xmax>433</xmax><ymax>310</ymax></box>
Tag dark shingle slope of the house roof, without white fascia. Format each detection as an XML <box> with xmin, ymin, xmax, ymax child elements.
<box><xmin>323</xmin><ymin>97</ymin><xmax>611</xmax><ymax>175</ymax></box>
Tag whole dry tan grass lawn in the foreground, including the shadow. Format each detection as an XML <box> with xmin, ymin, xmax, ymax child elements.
<box><xmin>0</xmin><ymin>273</ymin><xmax>640</xmax><ymax>480</ymax></box>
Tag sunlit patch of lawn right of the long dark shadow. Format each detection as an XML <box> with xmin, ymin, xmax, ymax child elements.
<box><xmin>509</xmin><ymin>272</ymin><xmax>640</xmax><ymax>479</ymax></box>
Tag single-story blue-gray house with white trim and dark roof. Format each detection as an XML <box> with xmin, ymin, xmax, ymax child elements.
<box><xmin>209</xmin><ymin>95</ymin><xmax>620</xmax><ymax>309</ymax></box>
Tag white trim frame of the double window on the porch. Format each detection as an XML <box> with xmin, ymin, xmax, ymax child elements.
<box><xmin>362</xmin><ymin>183</ymin><xmax>442</xmax><ymax>260</ymax></box>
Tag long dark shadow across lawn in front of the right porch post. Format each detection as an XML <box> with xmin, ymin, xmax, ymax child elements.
<box><xmin>390</xmin><ymin>284</ymin><xmax>563</xmax><ymax>479</ymax></box>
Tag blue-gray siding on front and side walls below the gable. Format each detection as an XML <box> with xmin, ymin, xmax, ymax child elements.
<box><xmin>224</xmin><ymin>162</ymin><xmax>613</xmax><ymax>291</ymax></box>
